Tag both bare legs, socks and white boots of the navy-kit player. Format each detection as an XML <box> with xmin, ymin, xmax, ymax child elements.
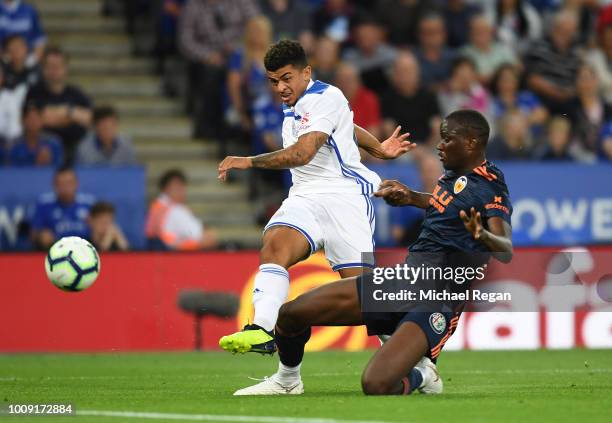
<box><xmin>234</xmin><ymin>278</ymin><xmax>442</xmax><ymax>395</ymax></box>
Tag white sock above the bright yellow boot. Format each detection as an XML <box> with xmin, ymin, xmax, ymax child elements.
<box><xmin>253</xmin><ymin>263</ymin><xmax>289</xmax><ymax>331</ymax></box>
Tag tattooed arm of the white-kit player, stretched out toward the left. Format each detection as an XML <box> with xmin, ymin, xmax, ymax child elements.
<box><xmin>218</xmin><ymin>131</ymin><xmax>329</xmax><ymax>181</ymax></box>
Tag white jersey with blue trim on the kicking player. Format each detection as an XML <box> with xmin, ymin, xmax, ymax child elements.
<box><xmin>283</xmin><ymin>81</ymin><xmax>380</xmax><ymax>196</ymax></box>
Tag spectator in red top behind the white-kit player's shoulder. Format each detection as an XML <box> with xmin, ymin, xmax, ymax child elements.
<box><xmin>335</xmin><ymin>62</ymin><xmax>382</xmax><ymax>139</ymax></box>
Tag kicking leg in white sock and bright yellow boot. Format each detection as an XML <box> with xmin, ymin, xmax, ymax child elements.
<box><xmin>219</xmin><ymin>226</ymin><xmax>312</xmax><ymax>354</ymax></box>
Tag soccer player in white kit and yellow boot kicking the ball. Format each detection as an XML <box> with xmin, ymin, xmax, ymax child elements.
<box><xmin>219</xmin><ymin>40</ymin><xmax>414</xmax><ymax>354</ymax></box>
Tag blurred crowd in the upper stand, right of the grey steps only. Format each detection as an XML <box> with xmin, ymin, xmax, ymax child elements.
<box><xmin>151</xmin><ymin>0</ymin><xmax>612</xmax><ymax>162</ymax></box>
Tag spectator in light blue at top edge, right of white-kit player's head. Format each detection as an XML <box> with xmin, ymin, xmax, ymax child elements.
<box><xmin>312</xmin><ymin>0</ymin><xmax>353</xmax><ymax>43</ymax></box>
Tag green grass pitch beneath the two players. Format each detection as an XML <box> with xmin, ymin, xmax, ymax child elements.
<box><xmin>0</xmin><ymin>350</ymin><xmax>612</xmax><ymax>423</ymax></box>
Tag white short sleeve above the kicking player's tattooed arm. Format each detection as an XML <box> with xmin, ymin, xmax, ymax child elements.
<box><xmin>297</xmin><ymin>93</ymin><xmax>349</xmax><ymax>138</ymax></box>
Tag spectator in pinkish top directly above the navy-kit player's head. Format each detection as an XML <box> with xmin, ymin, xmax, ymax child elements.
<box><xmin>438</xmin><ymin>57</ymin><xmax>492</xmax><ymax>125</ymax></box>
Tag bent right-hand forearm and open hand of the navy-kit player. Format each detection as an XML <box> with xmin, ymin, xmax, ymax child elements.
<box><xmin>459</xmin><ymin>207</ymin><xmax>512</xmax><ymax>263</ymax></box>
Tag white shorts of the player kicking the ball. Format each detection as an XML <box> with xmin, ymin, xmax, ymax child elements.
<box><xmin>264</xmin><ymin>194</ymin><xmax>375</xmax><ymax>271</ymax></box>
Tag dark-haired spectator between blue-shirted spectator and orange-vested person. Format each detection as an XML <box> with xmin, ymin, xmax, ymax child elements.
<box><xmin>87</xmin><ymin>201</ymin><xmax>130</xmax><ymax>252</ymax></box>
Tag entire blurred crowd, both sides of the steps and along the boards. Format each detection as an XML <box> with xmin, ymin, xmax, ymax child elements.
<box><xmin>0</xmin><ymin>0</ymin><xmax>612</xmax><ymax>249</ymax></box>
